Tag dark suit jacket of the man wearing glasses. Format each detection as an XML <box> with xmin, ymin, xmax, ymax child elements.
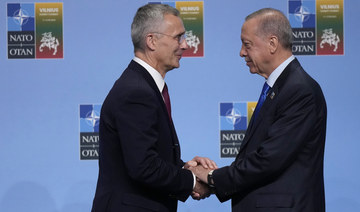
<box><xmin>92</xmin><ymin>61</ymin><xmax>194</xmax><ymax>212</ymax></box>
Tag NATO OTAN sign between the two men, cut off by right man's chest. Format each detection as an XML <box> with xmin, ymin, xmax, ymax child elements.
<box><xmin>220</xmin><ymin>102</ymin><xmax>257</xmax><ymax>158</ymax></box>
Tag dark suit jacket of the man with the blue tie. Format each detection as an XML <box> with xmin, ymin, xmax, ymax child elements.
<box><xmin>213</xmin><ymin>59</ymin><xmax>327</xmax><ymax>212</ymax></box>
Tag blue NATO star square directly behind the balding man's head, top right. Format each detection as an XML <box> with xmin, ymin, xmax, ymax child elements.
<box><xmin>289</xmin><ymin>0</ymin><xmax>316</xmax><ymax>28</ymax></box>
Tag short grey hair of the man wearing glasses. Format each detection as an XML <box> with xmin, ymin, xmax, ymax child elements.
<box><xmin>131</xmin><ymin>4</ymin><xmax>180</xmax><ymax>51</ymax></box>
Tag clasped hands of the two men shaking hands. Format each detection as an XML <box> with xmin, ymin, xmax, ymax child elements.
<box><xmin>184</xmin><ymin>156</ymin><xmax>218</xmax><ymax>200</ymax></box>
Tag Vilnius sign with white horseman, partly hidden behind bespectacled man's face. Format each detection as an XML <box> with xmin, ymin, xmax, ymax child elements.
<box><xmin>149</xmin><ymin>1</ymin><xmax>204</xmax><ymax>57</ymax></box>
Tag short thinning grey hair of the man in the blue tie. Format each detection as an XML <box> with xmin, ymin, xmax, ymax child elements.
<box><xmin>245</xmin><ymin>8</ymin><xmax>293</xmax><ymax>50</ymax></box>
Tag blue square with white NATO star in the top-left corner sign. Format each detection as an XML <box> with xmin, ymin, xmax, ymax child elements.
<box><xmin>7</xmin><ymin>3</ymin><xmax>35</xmax><ymax>31</ymax></box>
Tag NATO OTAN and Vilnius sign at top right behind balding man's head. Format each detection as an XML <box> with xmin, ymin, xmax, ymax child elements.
<box><xmin>288</xmin><ymin>0</ymin><xmax>344</xmax><ymax>55</ymax></box>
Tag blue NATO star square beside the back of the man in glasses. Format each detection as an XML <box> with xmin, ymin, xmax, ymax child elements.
<box><xmin>80</xmin><ymin>104</ymin><xmax>101</xmax><ymax>132</ymax></box>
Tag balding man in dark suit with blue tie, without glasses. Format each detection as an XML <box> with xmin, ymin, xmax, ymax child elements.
<box><xmin>191</xmin><ymin>8</ymin><xmax>327</xmax><ymax>212</ymax></box>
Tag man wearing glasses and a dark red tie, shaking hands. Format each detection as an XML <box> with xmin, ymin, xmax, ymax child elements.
<box><xmin>92</xmin><ymin>4</ymin><xmax>216</xmax><ymax>212</ymax></box>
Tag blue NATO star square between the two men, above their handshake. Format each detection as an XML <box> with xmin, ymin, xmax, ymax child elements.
<box><xmin>220</xmin><ymin>102</ymin><xmax>247</xmax><ymax>130</ymax></box>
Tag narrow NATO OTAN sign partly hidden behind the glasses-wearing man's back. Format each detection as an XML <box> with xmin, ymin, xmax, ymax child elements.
<box><xmin>79</xmin><ymin>104</ymin><xmax>101</xmax><ymax>160</ymax></box>
